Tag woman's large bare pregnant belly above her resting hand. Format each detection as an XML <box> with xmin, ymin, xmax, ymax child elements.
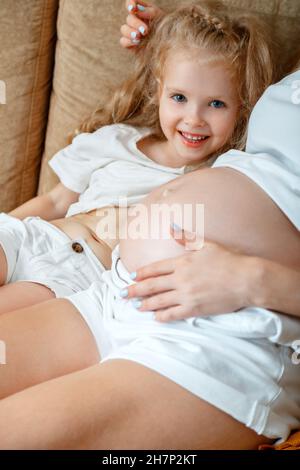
<box><xmin>120</xmin><ymin>168</ymin><xmax>300</xmax><ymax>272</ymax></box>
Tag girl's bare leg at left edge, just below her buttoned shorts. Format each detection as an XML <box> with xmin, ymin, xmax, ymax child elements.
<box><xmin>0</xmin><ymin>281</ymin><xmax>55</xmax><ymax>314</ymax></box>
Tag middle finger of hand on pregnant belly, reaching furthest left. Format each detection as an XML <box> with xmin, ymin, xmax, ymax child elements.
<box><xmin>127</xmin><ymin>275</ymin><xmax>174</xmax><ymax>299</ymax></box>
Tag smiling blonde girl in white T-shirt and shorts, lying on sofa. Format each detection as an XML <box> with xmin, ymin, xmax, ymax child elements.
<box><xmin>0</xmin><ymin>4</ymin><xmax>272</xmax><ymax>313</ymax></box>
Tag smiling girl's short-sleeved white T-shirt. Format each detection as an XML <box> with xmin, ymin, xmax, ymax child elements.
<box><xmin>49</xmin><ymin>124</ymin><xmax>197</xmax><ymax>217</ymax></box>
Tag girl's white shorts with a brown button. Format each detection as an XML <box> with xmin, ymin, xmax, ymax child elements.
<box><xmin>0</xmin><ymin>213</ymin><xmax>105</xmax><ymax>297</ymax></box>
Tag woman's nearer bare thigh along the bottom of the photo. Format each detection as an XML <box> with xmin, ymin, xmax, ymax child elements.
<box><xmin>0</xmin><ymin>360</ymin><xmax>269</xmax><ymax>449</ymax></box>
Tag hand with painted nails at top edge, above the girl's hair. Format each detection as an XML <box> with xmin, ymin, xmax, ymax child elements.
<box><xmin>120</xmin><ymin>0</ymin><xmax>162</xmax><ymax>48</ymax></box>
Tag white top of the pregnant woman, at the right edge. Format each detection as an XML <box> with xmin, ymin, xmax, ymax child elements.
<box><xmin>212</xmin><ymin>71</ymin><xmax>300</xmax><ymax>230</ymax></box>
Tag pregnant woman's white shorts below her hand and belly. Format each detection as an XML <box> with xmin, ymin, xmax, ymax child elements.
<box><xmin>68</xmin><ymin>247</ymin><xmax>300</xmax><ymax>440</ymax></box>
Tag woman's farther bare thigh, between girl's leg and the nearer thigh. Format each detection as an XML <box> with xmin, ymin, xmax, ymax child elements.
<box><xmin>0</xmin><ymin>299</ymin><xmax>100</xmax><ymax>399</ymax></box>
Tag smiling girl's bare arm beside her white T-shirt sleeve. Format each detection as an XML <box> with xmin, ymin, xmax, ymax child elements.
<box><xmin>9</xmin><ymin>183</ymin><xmax>79</xmax><ymax>220</ymax></box>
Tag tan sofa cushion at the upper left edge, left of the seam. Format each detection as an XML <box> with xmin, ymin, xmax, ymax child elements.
<box><xmin>0</xmin><ymin>0</ymin><xmax>58</xmax><ymax>211</ymax></box>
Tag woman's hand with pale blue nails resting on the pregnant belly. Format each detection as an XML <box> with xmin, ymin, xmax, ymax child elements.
<box><xmin>123</xmin><ymin>225</ymin><xmax>255</xmax><ymax>322</ymax></box>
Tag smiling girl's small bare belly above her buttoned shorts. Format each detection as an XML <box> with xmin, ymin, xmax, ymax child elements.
<box><xmin>50</xmin><ymin>207</ymin><xmax>126</xmax><ymax>269</ymax></box>
